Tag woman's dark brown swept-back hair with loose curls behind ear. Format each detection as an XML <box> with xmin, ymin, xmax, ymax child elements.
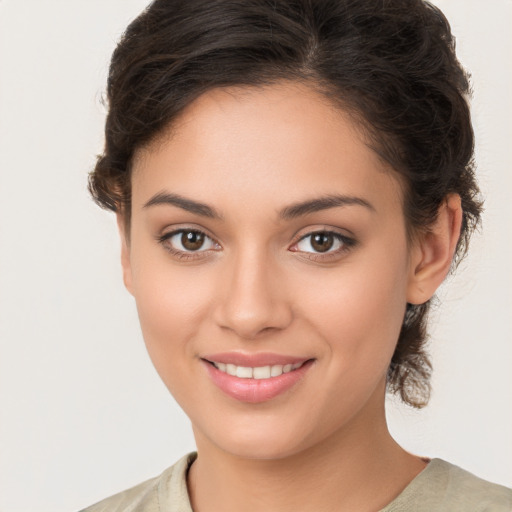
<box><xmin>89</xmin><ymin>0</ymin><xmax>481</xmax><ymax>407</ymax></box>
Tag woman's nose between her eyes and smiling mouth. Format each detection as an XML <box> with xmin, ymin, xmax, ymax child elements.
<box><xmin>215</xmin><ymin>245</ymin><xmax>293</xmax><ymax>339</ymax></box>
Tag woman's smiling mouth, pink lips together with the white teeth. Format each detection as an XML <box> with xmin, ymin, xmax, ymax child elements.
<box><xmin>202</xmin><ymin>353</ymin><xmax>313</xmax><ymax>403</ymax></box>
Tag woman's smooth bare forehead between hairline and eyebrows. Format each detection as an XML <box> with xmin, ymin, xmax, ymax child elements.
<box><xmin>133</xmin><ymin>82</ymin><xmax>401</xmax><ymax>217</ymax></box>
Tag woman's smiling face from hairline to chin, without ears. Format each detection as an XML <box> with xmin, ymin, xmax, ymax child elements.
<box><xmin>123</xmin><ymin>83</ymin><xmax>420</xmax><ymax>458</ymax></box>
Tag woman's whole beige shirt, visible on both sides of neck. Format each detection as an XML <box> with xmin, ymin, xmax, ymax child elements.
<box><xmin>82</xmin><ymin>453</ymin><xmax>512</xmax><ymax>512</ymax></box>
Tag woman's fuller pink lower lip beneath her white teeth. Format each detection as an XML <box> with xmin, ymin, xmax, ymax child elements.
<box><xmin>203</xmin><ymin>360</ymin><xmax>313</xmax><ymax>404</ymax></box>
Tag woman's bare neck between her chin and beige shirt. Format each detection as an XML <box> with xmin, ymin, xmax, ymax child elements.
<box><xmin>188</xmin><ymin>388</ymin><xmax>425</xmax><ymax>512</ymax></box>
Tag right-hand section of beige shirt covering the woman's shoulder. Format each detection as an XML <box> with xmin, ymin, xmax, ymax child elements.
<box><xmin>382</xmin><ymin>459</ymin><xmax>512</xmax><ymax>512</ymax></box>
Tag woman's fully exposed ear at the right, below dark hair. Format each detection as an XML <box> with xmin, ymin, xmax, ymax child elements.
<box><xmin>407</xmin><ymin>194</ymin><xmax>462</xmax><ymax>304</ymax></box>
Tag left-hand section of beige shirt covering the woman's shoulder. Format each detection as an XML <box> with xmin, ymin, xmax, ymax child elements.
<box><xmin>81</xmin><ymin>453</ymin><xmax>196</xmax><ymax>512</ymax></box>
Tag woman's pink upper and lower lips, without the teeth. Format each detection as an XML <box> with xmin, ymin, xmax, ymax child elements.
<box><xmin>203</xmin><ymin>352</ymin><xmax>313</xmax><ymax>403</ymax></box>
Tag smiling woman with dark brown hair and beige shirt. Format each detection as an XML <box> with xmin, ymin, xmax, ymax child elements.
<box><xmin>82</xmin><ymin>0</ymin><xmax>512</xmax><ymax>512</ymax></box>
